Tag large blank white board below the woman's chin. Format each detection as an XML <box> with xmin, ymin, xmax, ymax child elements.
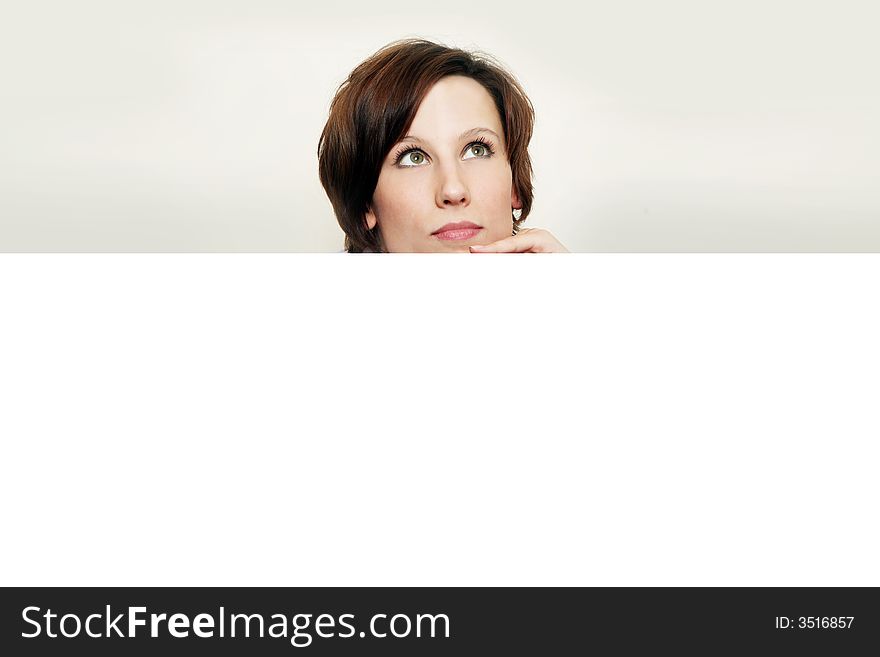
<box><xmin>0</xmin><ymin>254</ymin><xmax>880</xmax><ymax>586</ymax></box>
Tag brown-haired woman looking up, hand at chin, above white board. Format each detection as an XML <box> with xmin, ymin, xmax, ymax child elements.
<box><xmin>318</xmin><ymin>39</ymin><xmax>566</xmax><ymax>253</ymax></box>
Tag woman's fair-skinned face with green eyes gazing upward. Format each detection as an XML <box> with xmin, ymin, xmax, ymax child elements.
<box><xmin>366</xmin><ymin>75</ymin><xmax>521</xmax><ymax>252</ymax></box>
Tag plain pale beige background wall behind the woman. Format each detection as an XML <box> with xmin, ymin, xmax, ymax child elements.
<box><xmin>0</xmin><ymin>0</ymin><xmax>880</xmax><ymax>251</ymax></box>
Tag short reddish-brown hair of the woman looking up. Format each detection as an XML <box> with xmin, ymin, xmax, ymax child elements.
<box><xmin>318</xmin><ymin>39</ymin><xmax>535</xmax><ymax>252</ymax></box>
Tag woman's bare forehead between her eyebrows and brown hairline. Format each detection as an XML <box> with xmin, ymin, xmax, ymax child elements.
<box><xmin>410</xmin><ymin>75</ymin><xmax>503</xmax><ymax>138</ymax></box>
